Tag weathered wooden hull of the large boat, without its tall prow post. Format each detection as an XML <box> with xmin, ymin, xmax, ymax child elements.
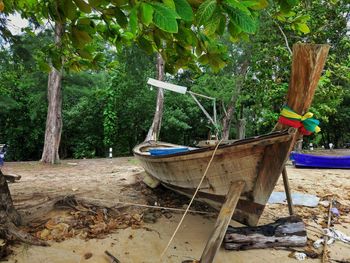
<box><xmin>134</xmin><ymin>132</ymin><xmax>295</xmax><ymax>225</ymax></box>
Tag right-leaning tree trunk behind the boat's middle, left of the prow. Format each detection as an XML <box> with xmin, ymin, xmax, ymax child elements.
<box><xmin>222</xmin><ymin>60</ymin><xmax>249</xmax><ymax>140</ymax></box>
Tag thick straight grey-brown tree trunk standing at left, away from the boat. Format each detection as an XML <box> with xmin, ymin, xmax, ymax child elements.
<box><xmin>41</xmin><ymin>22</ymin><xmax>64</xmax><ymax>164</ymax></box>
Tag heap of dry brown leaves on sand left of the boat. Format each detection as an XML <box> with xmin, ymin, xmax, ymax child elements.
<box><xmin>27</xmin><ymin>196</ymin><xmax>143</xmax><ymax>241</ymax></box>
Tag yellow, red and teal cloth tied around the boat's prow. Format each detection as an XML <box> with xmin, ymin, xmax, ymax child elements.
<box><xmin>278</xmin><ymin>106</ymin><xmax>321</xmax><ymax>135</ymax></box>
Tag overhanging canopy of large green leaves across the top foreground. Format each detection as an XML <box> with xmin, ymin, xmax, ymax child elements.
<box><xmin>0</xmin><ymin>0</ymin><xmax>300</xmax><ymax>73</ymax></box>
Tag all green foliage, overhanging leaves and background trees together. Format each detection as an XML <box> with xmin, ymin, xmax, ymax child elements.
<box><xmin>0</xmin><ymin>0</ymin><xmax>350</xmax><ymax>160</ymax></box>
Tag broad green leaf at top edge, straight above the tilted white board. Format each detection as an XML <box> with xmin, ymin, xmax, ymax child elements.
<box><xmin>152</xmin><ymin>3</ymin><xmax>179</xmax><ymax>33</ymax></box>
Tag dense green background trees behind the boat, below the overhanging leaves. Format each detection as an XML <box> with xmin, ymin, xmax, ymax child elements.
<box><xmin>0</xmin><ymin>1</ymin><xmax>350</xmax><ymax>160</ymax></box>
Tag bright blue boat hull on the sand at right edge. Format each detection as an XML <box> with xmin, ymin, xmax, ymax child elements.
<box><xmin>291</xmin><ymin>152</ymin><xmax>350</xmax><ymax>169</ymax></box>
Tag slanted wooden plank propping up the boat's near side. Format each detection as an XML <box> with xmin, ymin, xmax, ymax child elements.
<box><xmin>200</xmin><ymin>181</ymin><xmax>245</xmax><ymax>263</ymax></box>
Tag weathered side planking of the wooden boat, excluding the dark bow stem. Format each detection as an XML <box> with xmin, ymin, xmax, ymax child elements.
<box><xmin>135</xmin><ymin>133</ymin><xmax>291</xmax><ymax>199</ymax></box>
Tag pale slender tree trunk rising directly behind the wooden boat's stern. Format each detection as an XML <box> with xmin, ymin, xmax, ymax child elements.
<box><xmin>145</xmin><ymin>53</ymin><xmax>164</xmax><ymax>141</ymax></box>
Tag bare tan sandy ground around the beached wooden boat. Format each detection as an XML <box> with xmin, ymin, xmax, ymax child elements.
<box><xmin>3</xmin><ymin>157</ymin><xmax>350</xmax><ymax>263</ymax></box>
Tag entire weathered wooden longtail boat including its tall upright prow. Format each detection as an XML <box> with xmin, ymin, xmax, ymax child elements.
<box><xmin>134</xmin><ymin>44</ymin><xmax>329</xmax><ymax>231</ymax></box>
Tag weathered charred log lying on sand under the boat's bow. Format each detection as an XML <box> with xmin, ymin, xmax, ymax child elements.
<box><xmin>224</xmin><ymin>216</ymin><xmax>307</xmax><ymax>250</ymax></box>
